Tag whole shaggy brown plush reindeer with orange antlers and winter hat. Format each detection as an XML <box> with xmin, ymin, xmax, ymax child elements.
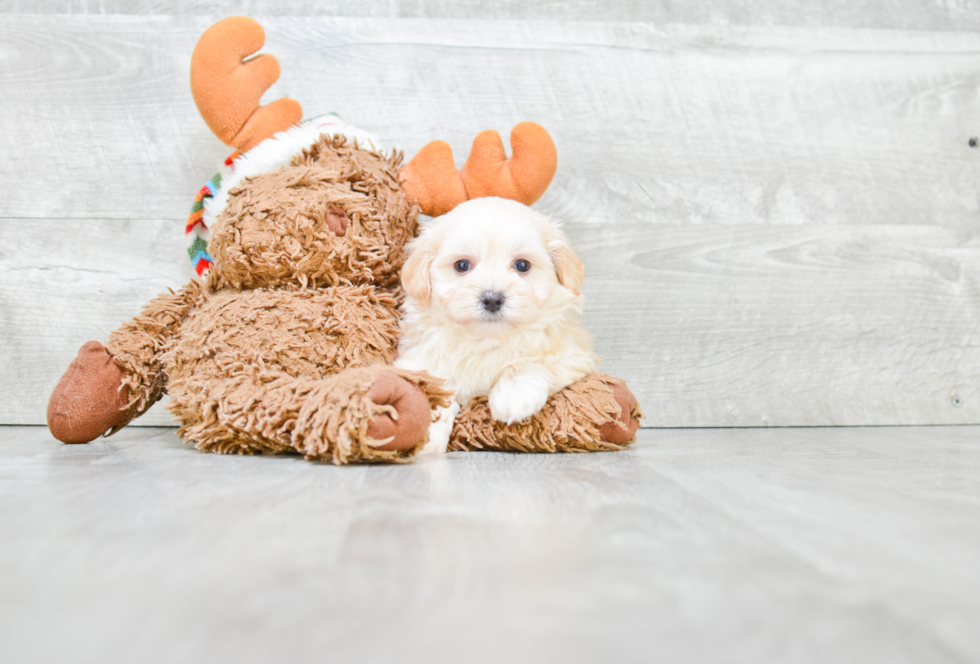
<box><xmin>48</xmin><ymin>17</ymin><xmax>639</xmax><ymax>464</ymax></box>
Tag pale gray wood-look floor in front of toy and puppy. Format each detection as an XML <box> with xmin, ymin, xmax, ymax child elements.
<box><xmin>0</xmin><ymin>427</ymin><xmax>980</xmax><ymax>663</ymax></box>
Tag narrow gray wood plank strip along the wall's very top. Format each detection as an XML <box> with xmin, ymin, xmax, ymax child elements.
<box><xmin>0</xmin><ymin>0</ymin><xmax>980</xmax><ymax>32</ymax></box>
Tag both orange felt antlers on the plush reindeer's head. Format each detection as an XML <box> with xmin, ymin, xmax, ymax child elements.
<box><xmin>191</xmin><ymin>16</ymin><xmax>558</xmax><ymax>217</ymax></box>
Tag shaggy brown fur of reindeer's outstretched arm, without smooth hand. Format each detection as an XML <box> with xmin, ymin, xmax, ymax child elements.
<box><xmin>106</xmin><ymin>279</ymin><xmax>204</xmax><ymax>434</ymax></box>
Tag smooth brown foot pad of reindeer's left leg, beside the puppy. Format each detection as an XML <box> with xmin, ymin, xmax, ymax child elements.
<box><xmin>368</xmin><ymin>371</ymin><xmax>432</xmax><ymax>451</ymax></box>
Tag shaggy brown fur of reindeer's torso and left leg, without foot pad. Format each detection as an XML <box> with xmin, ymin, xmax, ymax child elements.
<box><xmin>163</xmin><ymin>285</ymin><xmax>436</xmax><ymax>463</ymax></box>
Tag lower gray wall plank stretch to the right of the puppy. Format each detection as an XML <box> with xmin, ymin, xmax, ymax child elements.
<box><xmin>572</xmin><ymin>220</ymin><xmax>980</xmax><ymax>426</ymax></box>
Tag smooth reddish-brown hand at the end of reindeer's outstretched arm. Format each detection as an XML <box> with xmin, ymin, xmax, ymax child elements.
<box><xmin>48</xmin><ymin>341</ymin><xmax>129</xmax><ymax>443</ymax></box>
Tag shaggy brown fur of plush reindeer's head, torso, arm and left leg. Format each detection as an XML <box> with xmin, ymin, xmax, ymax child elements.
<box><xmin>84</xmin><ymin>137</ymin><xmax>446</xmax><ymax>463</ymax></box>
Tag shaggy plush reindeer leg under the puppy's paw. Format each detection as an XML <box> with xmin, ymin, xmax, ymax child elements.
<box><xmin>449</xmin><ymin>374</ymin><xmax>643</xmax><ymax>452</ymax></box>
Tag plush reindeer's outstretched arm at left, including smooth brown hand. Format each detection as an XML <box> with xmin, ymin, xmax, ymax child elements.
<box><xmin>48</xmin><ymin>280</ymin><xmax>203</xmax><ymax>443</ymax></box>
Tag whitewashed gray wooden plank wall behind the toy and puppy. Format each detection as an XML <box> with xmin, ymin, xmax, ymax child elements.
<box><xmin>0</xmin><ymin>6</ymin><xmax>980</xmax><ymax>426</ymax></box>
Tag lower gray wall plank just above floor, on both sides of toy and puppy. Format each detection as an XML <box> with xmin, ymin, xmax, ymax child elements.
<box><xmin>0</xmin><ymin>219</ymin><xmax>980</xmax><ymax>427</ymax></box>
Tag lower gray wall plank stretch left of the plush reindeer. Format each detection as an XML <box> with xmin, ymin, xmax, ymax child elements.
<box><xmin>0</xmin><ymin>219</ymin><xmax>193</xmax><ymax>425</ymax></box>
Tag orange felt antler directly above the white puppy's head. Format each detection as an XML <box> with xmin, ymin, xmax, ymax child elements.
<box><xmin>400</xmin><ymin>122</ymin><xmax>558</xmax><ymax>217</ymax></box>
